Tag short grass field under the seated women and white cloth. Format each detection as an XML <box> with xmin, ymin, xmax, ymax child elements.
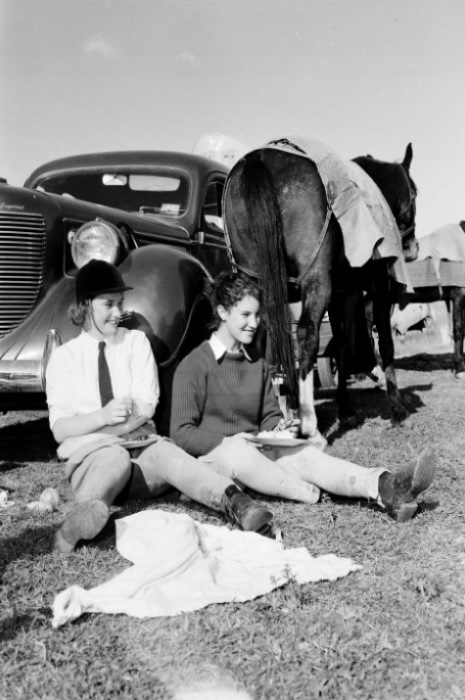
<box><xmin>0</xmin><ymin>330</ymin><xmax>465</xmax><ymax>700</ymax></box>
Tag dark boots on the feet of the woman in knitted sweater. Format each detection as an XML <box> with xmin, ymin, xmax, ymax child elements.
<box><xmin>378</xmin><ymin>447</ymin><xmax>436</xmax><ymax>523</ymax></box>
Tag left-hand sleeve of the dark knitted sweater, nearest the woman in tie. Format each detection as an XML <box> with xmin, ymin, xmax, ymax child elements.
<box><xmin>170</xmin><ymin>351</ymin><xmax>224</xmax><ymax>457</ymax></box>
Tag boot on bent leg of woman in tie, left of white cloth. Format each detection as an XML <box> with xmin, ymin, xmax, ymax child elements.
<box><xmin>52</xmin><ymin>500</ymin><xmax>110</xmax><ymax>554</ymax></box>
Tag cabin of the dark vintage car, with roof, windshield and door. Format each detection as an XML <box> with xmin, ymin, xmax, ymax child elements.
<box><xmin>24</xmin><ymin>151</ymin><xmax>228</xmax><ymax>270</ymax></box>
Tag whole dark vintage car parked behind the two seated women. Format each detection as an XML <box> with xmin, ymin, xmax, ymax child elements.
<box><xmin>0</xmin><ymin>151</ymin><xmax>229</xmax><ymax>429</ymax></box>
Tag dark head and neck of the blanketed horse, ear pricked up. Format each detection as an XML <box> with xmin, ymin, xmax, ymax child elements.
<box><xmin>354</xmin><ymin>143</ymin><xmax>418</xmax><ymax>262</ymax></box>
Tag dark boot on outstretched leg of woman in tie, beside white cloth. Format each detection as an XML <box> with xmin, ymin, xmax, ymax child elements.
<box><xmin>221</xmin><ymin>484</ymin><xmax>276</xmax><ymax>538</ymax></box>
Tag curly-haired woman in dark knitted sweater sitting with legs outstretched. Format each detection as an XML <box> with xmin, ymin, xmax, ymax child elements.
<box><xmin>171</xmin><ymin>273</ymin><xmax>434</xmax><ymax>522</ymax></box>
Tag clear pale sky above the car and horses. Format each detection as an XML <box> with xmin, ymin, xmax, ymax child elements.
<box><xmin>0</xmin><ymin>0</ymin><xmax>465</xmax><ymax>236</ymax></box>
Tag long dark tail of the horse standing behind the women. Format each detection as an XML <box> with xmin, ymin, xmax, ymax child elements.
<box><xmin>240</xmin><ymin>152</ymin><xmax>298</xmax><ymax>408</ymax></box>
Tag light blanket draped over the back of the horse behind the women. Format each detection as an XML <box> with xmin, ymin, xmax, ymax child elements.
<box><xmin>264</xmin><ymin>136</ymin><xmax>413</xmax><ymax>291</ymax></box>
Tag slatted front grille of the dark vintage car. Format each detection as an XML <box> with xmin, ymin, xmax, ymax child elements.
<box><xmin>0</xmin><ymin>211</ymin><xmax>45</xmax><ymax>336</ymax></box>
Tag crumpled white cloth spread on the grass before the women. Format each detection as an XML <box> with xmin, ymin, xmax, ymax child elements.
<box><xmin>52</xmin><ymin>510</ymin><xmax>361</xmax><ymax>628</ymax></box>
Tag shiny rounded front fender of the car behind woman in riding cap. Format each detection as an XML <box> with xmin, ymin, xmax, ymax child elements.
<box><xmin>0</xmin><ymin>244</ymin><xmax>210</xmax><ymax>392</ymax></box>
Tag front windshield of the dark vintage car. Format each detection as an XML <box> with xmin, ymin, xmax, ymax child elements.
<box><xmin>38</xmin><ymin>172</ymin><xmax>189</xmax><ymax>217</ymax></box>
